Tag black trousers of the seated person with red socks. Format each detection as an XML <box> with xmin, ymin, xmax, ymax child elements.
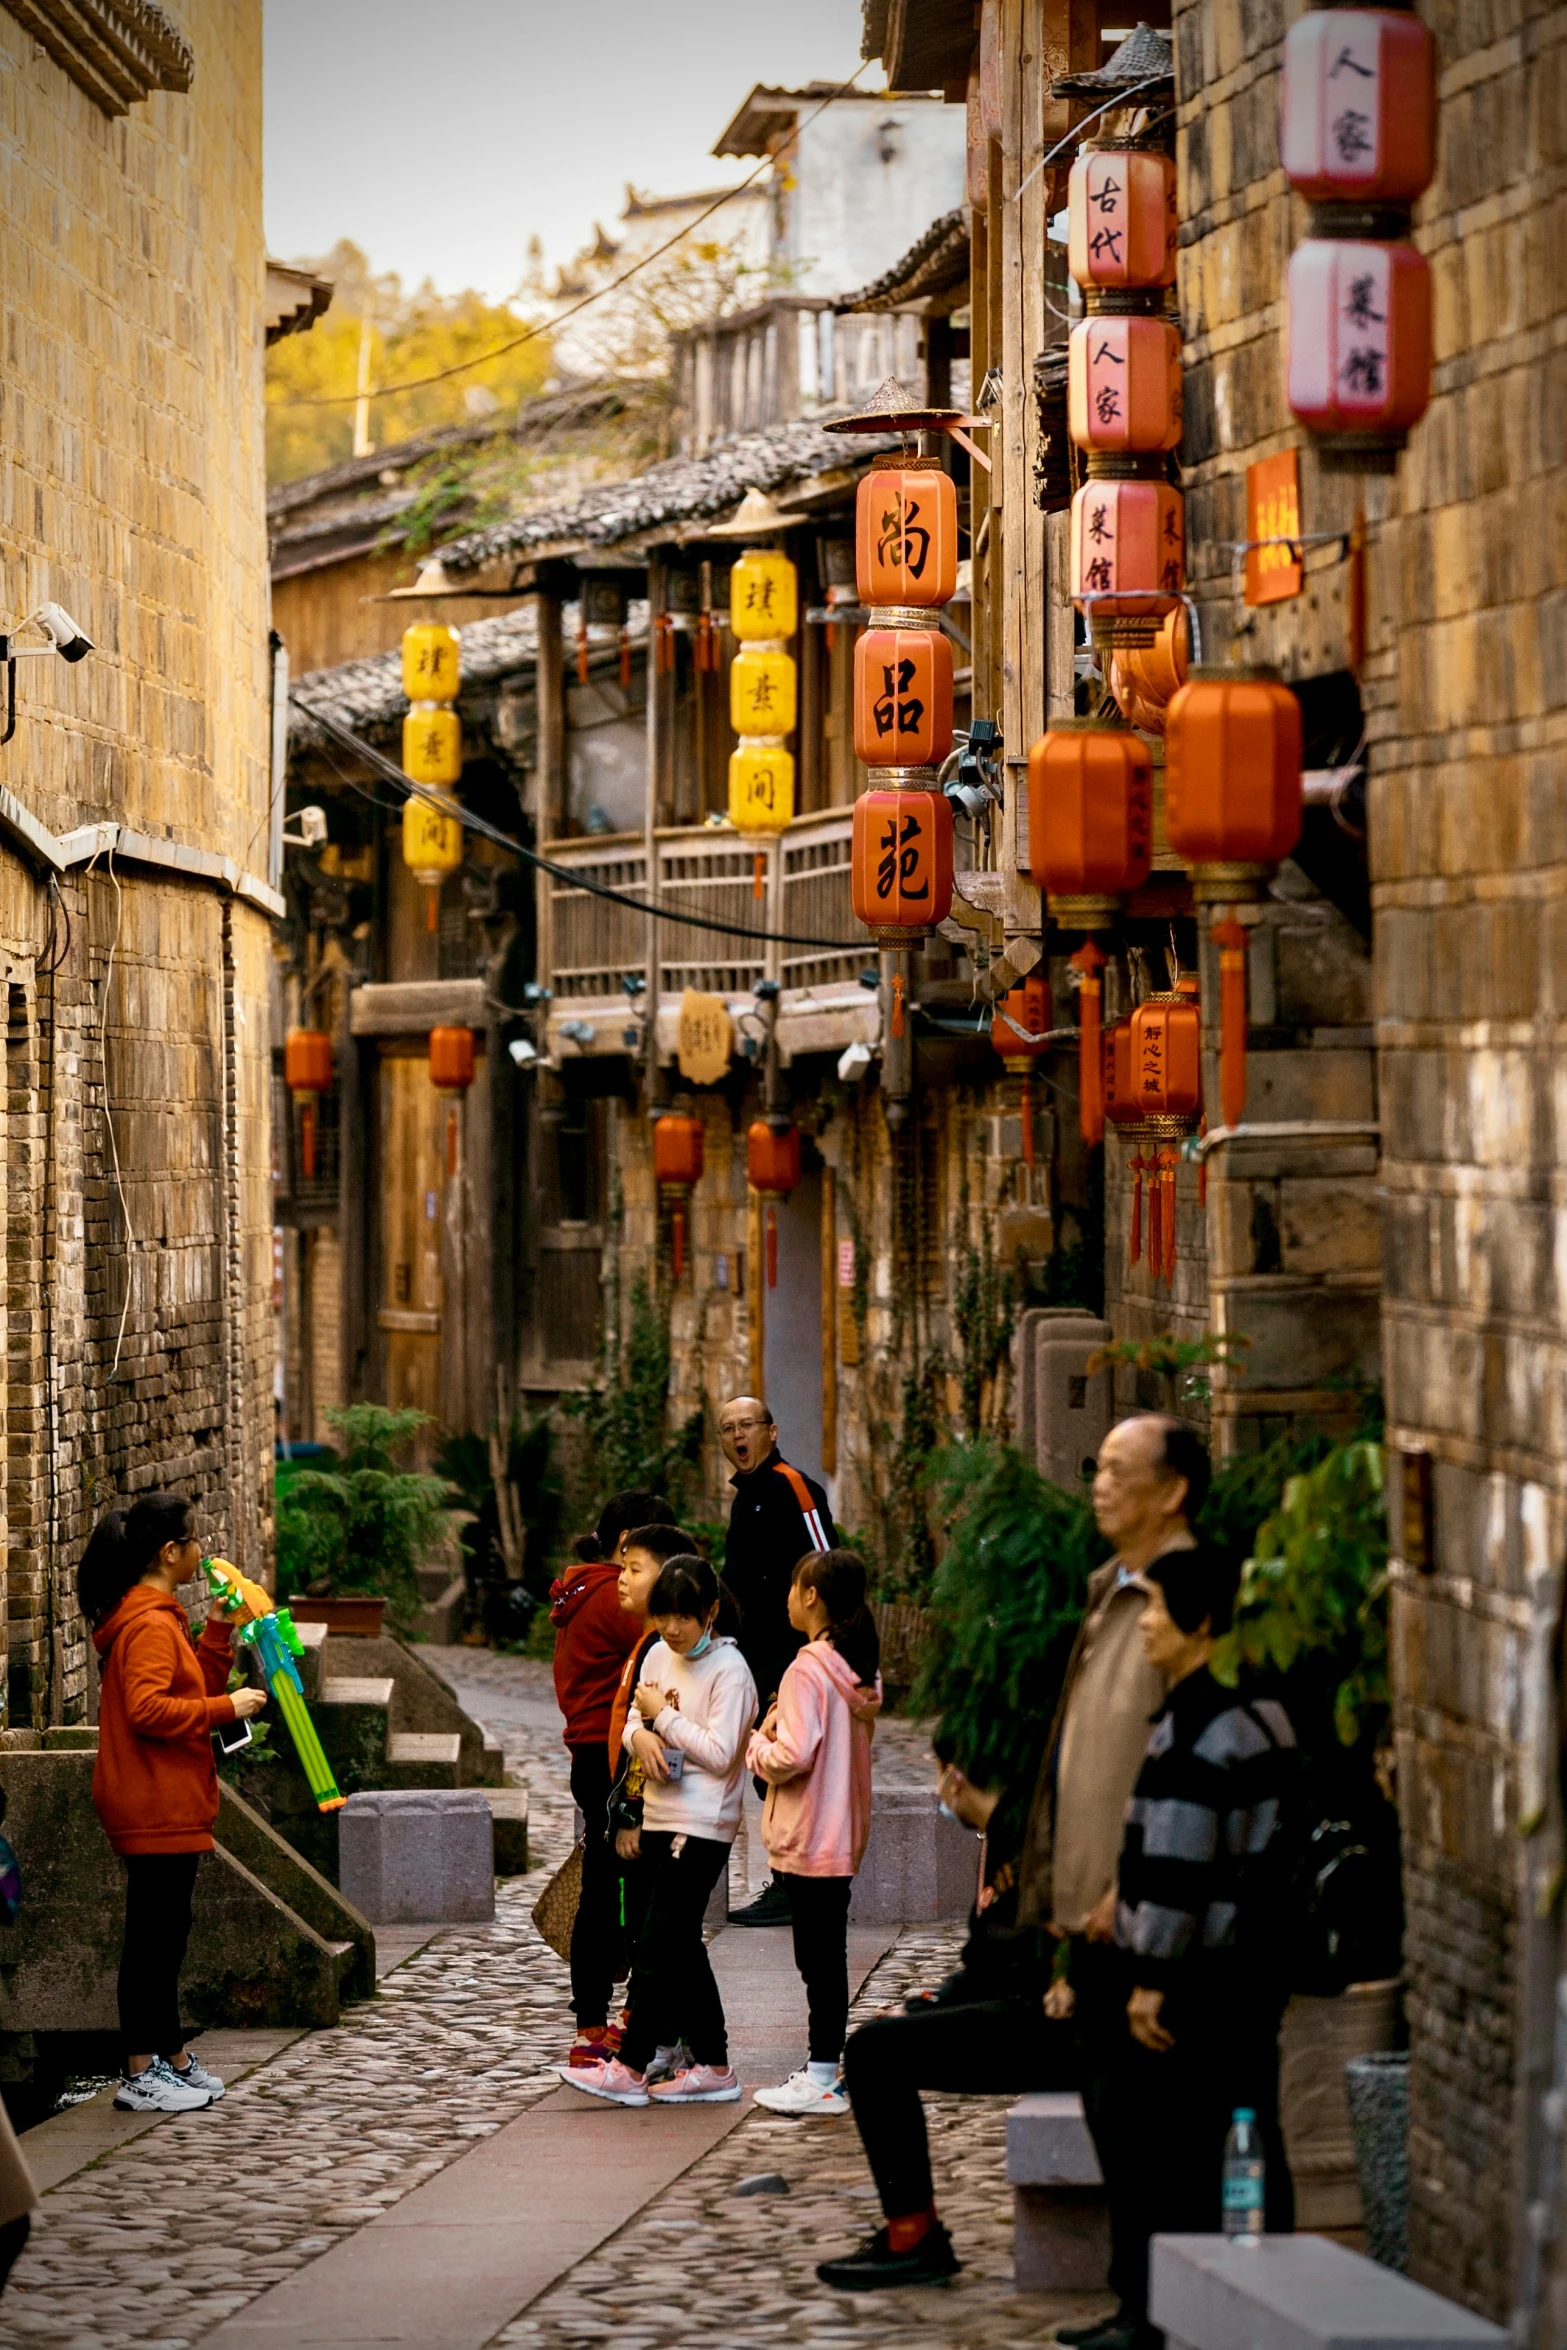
<box><xmin>843</xmin><ymin>1983</ymin><xmax>1076</xmax><ymax>2218</ymax></box>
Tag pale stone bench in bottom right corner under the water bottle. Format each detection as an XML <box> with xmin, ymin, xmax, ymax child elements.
<box><xmin>1149</xmin><ymin>2235</ymin><xmax>1508</xmax><ymax>2350</ymax></box>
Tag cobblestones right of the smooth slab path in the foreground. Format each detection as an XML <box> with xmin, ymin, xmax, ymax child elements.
<box><xmin>491</xmin><ymin>1927</ymin><xmax>1111</xmax><ymax>2350</ymax></box>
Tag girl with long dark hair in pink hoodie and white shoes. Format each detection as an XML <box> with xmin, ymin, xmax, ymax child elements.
<box><xmin>745</xmin><ymin>1551</ymin><xmax>881</xmax><ymax>2115</ymax></box>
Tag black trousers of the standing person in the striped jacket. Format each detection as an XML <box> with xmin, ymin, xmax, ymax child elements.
<box><xmin>1099</xmin><ymin>1974</ymin><xmax>1294</xmax><ymax>2324</ymax></box>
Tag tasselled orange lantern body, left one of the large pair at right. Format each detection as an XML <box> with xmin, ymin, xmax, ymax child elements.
<box><xmin>1029</xmin><ymin>719</ymin><xmax>1154</xmax><ymax>928</ymax></box>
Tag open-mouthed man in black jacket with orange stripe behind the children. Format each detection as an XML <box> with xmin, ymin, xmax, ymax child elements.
<box><xmin>719</xmin><ymin>1396</ymin><xmax>839</xmax><ymax>1925</ymax></box>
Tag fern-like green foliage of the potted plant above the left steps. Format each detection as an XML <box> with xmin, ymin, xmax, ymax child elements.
<box><xmin>277</xmin><ymin>1403</ymin><xmax>451</xmax><ymax>1622</ymax></box>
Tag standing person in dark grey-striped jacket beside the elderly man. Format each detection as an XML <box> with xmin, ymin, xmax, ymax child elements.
<box><xmin>1095</xmin><ymin>1549</ymin><xmax>1297</xmax><ymax>2350</ymax></box>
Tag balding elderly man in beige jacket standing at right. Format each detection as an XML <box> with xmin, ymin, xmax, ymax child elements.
<box><xmin>1020</xmin><ymin>1412</ymin><xmax>1210</xmax><ymax>2350</ymax></box>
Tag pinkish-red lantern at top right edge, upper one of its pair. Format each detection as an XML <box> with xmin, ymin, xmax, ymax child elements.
<box><xmin>1278</xmin><ymin>7</ymin><xmax>1435</xmax><ymax>204</ymax></box>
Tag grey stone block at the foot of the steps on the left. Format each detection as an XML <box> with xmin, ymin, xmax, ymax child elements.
<box><xmin>338</xmin><ymin>1788</ymin><xmax>496</xmax><ymax>1925</ymax></box>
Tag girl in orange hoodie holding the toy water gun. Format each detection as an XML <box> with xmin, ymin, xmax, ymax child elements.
<box><xmin>75</xmin><ymin>1492</ymin><xmax>265</xmax><ymax>2113</ymax></box>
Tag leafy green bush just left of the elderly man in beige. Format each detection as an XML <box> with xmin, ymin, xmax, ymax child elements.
<box><xmin>909</xmin><ymin>1436</ymin><xmax>1107</xmax><ymax>1786</ymax></box>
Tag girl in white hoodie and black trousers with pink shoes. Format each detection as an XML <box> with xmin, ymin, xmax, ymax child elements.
<box><xmin>561</xmin><ymin>1556</ymin><xmax>756</xmax><ymax>2106</ymax></box>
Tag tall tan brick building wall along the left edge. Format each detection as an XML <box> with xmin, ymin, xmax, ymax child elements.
<box><xmin>0</xmin><ymin>0</ymin><xmax>273</xmax><ymax>1725</ymax></box>
